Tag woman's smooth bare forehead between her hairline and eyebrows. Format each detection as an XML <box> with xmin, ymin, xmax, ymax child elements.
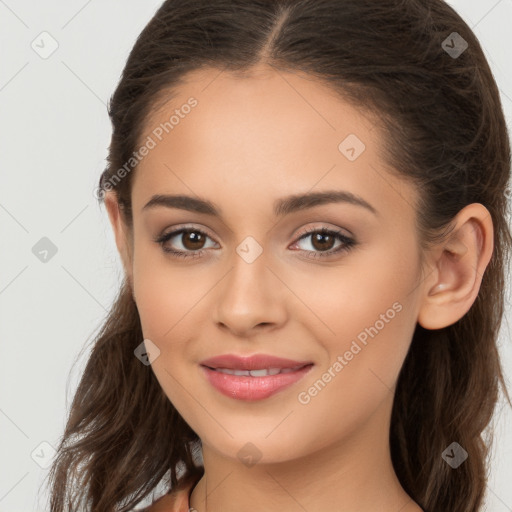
<box><xmin>132</xmin><ymin>64</ymin><xmax>411</xmax><ymax>222</ymax></box>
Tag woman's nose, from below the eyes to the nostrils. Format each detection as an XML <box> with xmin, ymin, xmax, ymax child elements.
<box><xmin>214</xmin><ymin>247</ymin><xmax>290</xmax><ymax>337</ymax></box>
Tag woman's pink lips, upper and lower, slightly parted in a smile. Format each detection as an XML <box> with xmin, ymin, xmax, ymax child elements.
<box><xmin>201</xmin><ymin>354</ymin><xmax>314</xmax><ymax>401</ymax></box>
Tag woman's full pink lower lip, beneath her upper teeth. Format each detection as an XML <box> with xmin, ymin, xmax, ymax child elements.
<box><xmin>201</xmin><ymin>364</ymin><xmax>313</xmax><ymax>401</ymax></box>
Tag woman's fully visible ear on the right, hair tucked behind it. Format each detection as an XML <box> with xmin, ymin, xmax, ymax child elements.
<box><xmin>418</xmin><ymin>203</ymin><xmax>494</xmax><ymax>329</ymax></box>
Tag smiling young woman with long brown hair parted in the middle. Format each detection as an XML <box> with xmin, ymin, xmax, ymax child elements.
<box><xmin>46</xmin><ymin>0</ymin><xmax>511</xmax><ymax>512</ymax></box>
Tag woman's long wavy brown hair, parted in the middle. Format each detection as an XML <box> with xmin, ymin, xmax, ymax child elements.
<box><xmin>49</xmin><ymin>0</ymin><xmax>512</xmax><ymax>512</ymax></box>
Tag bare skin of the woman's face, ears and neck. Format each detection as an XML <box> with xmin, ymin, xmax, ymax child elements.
<box><xmin>105</xmin><ymin>68</ymin><xmax>493</xmax><ymax>512</ymax></box>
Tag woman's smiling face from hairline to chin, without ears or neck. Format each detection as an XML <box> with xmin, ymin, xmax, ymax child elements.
<box><xmin>121</xmin><ymin>65</ymin><xmax>425</xmax><ymax>462</ymax></box>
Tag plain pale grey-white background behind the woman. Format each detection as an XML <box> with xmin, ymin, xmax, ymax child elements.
<box><xmin>0</xmin><ymin>0</ymin><xmax>512</xmax><ymax>512</ymax></box>
